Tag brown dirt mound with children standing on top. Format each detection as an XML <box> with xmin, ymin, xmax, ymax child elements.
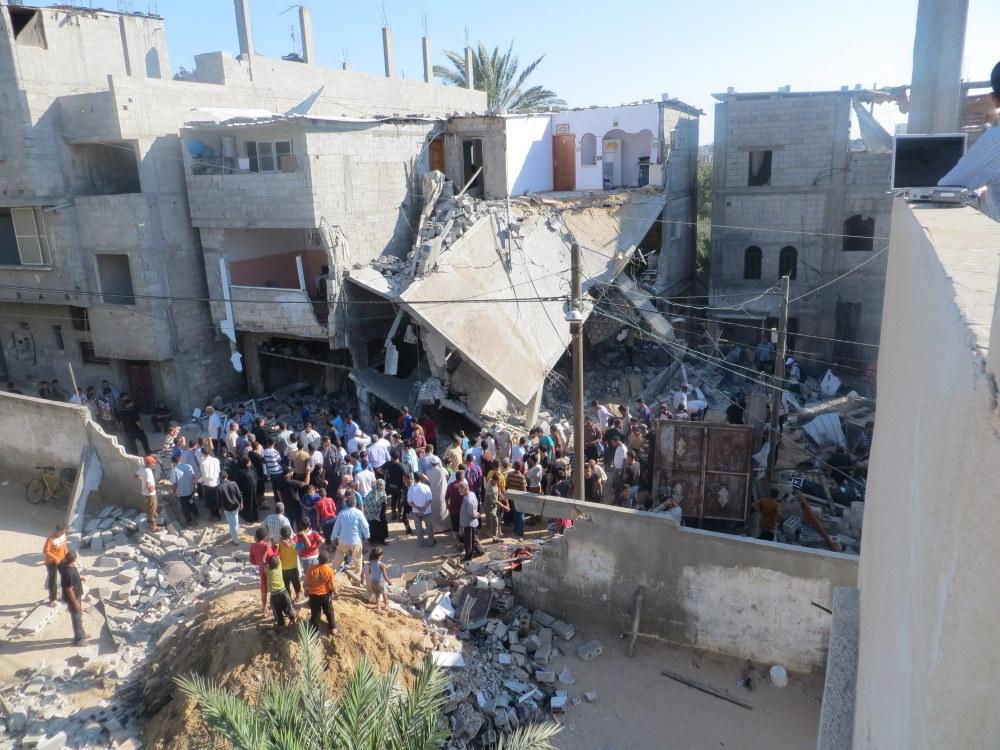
<box><xmin>140</xmin><ymin>589</ymin><xmax>434</xmax><ymax>750</ymax></box>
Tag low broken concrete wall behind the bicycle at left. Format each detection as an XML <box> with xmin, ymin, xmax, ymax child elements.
<box><xmin>0</xmin><ymin>392</ymin><xmax>142</xmax><ymax>507</ymax></box>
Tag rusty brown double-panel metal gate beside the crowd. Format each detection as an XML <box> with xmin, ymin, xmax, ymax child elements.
<box><xmin>653</xmin><ymin>419</ymin><xmax>753</xmax><ymax>521</ymax></box>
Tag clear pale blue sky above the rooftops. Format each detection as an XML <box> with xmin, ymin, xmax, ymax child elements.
<box><xmin>35</xmin><ymin>0</ymin><xmax>1000</xmax><ymax>143</ymax></box>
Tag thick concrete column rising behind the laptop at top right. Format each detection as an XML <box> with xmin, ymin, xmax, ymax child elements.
<box><xmin>907</xmin><ymin>0</ymin><xmax>969</xmax><ymax>133</ymax></box>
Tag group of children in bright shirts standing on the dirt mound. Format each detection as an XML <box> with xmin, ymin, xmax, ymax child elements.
<box><xmin>250</xmin><ymin>524</ymin><xmax>392</xmax><ymax>635</ymax></box>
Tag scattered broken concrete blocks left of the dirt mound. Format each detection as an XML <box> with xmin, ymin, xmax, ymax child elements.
<box><xmin>0</xmin><ymin>506</ymin><xmax>258</xmax><ymax>750</ymax></box>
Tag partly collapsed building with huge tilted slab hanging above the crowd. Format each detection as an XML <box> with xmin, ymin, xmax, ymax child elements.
<box><xmin>189</xmin><ymin>100</ymin><xmax>699</xmax><ymax>420</ymax></box>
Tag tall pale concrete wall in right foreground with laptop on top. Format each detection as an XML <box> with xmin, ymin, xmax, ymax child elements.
<box><xmin>854</xmin><ymin>200</ymin><xmax>1000</xmax><ymax>750</ymax></box>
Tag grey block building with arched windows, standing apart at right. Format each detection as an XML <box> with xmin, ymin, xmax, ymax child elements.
<box><xmin>709</xmin><ymin>87</ymin><xmax>898</xmax><ymax>373</ymax></box>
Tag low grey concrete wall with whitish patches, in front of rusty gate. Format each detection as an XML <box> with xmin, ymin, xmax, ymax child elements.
<box><xmin>510</xmin><ymin>492</ymin><xmax>858</xmax><ymax>671</ymax></box>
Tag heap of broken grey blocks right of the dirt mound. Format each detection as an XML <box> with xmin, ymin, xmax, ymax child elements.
<box><xmin>392</xmin><ymin>545</ymin><xmax>602</xmax><ymax>750</ymax></box>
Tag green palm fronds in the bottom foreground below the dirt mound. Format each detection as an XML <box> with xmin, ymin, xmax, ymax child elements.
<box><xmin>176</xmin><ymin>622</ymin><xmax>561</xmax><ymax>750</ymax></box>
